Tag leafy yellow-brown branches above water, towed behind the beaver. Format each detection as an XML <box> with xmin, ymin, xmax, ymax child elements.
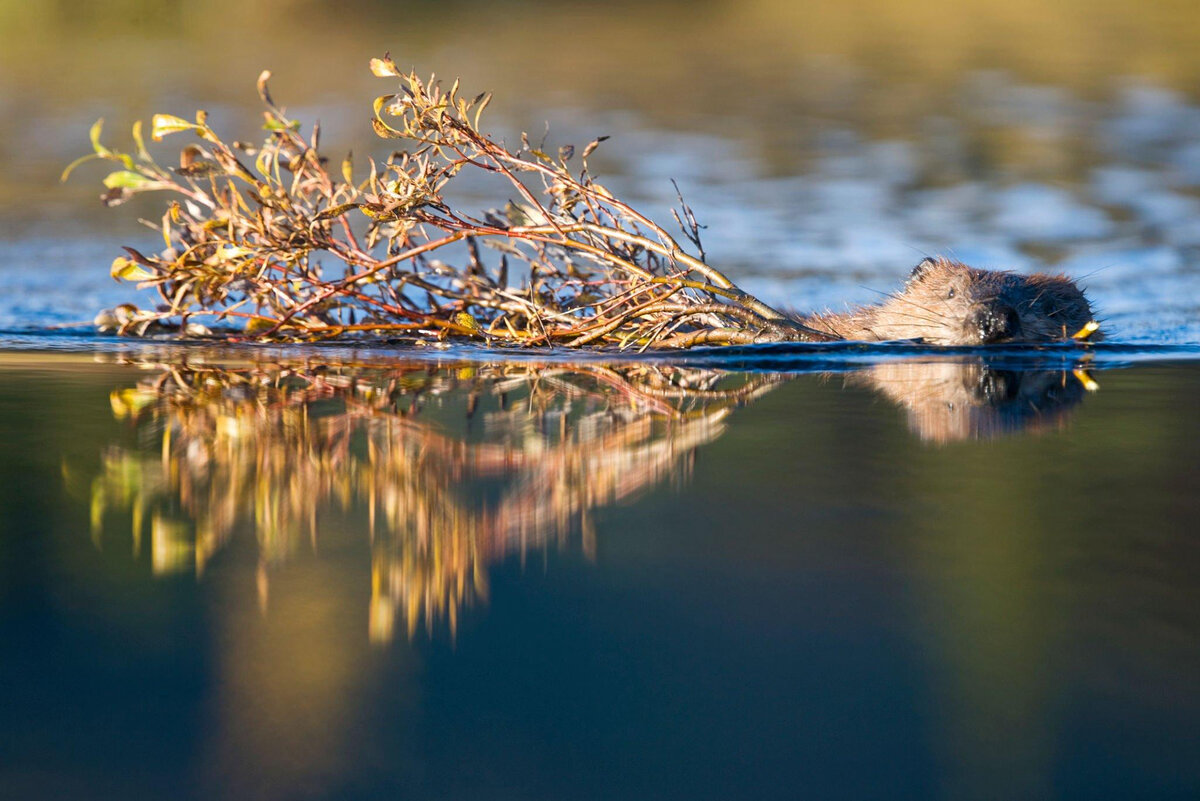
<box><xmin>64</xmin><ymin>56</ymin><xmax>830</xmax><ymax>349</ymax></box>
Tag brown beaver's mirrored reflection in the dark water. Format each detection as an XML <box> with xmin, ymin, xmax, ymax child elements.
<box><xmin>846</xmin><ymin>360</ymin><xmax>1096</xmax><ymax>442</ymax></box>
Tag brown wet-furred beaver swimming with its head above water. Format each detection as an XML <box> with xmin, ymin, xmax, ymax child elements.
<box><xmin>796</xmin><ymin>258</ymin><xmax>1100</xmax><ymax>345</ymax></box>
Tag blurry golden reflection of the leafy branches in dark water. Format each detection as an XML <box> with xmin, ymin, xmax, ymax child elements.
<box><xmin>92</xmin><ymin>363</ymin><xmax>775</xmax><ymax>639</ymax></box>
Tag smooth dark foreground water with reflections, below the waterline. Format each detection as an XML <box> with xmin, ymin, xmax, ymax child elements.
<box><xmin>0</xmin><ymin>350</ymin><xmax>1200</xmax><ymax>799</ymax></box>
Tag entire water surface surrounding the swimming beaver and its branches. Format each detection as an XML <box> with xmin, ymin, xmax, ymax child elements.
<box><xmin>0</xmin><ymin>0</ymin><xmax>1200</xmax><ymax>799</ymax></box>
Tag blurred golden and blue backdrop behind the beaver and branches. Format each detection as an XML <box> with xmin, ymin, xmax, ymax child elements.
<box><xmin>0</xmin><ymin>0</ymin><xmax>1200</xmax><ymax>343</ymax></box>
